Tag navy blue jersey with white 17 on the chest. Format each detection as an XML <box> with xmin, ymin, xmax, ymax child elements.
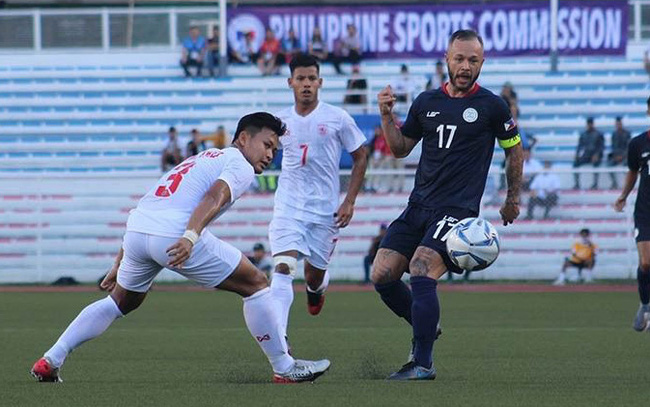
<box><xmin>401</xmin><ymin>85</ymin><xmax>519</xmax><ymax>212</ymax></box>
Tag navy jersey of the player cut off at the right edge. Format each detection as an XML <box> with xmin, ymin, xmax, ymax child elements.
<box><xmin>627</xmin><ymin>131</ymin><xmax>650</xmax><ymax>221</ymax></box>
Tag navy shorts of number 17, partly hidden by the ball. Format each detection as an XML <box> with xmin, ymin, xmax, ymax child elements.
<box><xmin>379</xmin><ymin>204</ymin><xmax>478</xmax><ymax>274</ymax></box>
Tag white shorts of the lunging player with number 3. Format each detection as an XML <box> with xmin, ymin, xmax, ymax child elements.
<box><xmin>117</xmin><ymin>232</ymin><xmax>242</xmax><ymax>293</ymax></box>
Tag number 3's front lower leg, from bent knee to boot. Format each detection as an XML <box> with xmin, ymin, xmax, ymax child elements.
<box><xmin>219</xmin><ymin>256</ymin><xmax>330</xmax><ymax>383</ymax></box>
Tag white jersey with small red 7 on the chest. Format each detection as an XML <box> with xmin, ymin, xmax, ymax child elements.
<box><xmin>274</xmin><ymin>102</ymin><xmax>366</xmax><ymax>225</ymax></box>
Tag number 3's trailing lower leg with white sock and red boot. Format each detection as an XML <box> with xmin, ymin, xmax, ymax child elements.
<box><xmin>31</xmin><ymin>285</ymin><xmax>141</xmax><ymax>382</ymax></box>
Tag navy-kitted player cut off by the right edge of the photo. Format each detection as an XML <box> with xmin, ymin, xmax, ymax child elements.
<box><xmin>614</xmin><ymin>98</ymin><xmax>650</xmax><ymax>332</ymax></box>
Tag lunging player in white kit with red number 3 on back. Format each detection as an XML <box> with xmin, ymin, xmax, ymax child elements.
<box><xmin>31</xmin><ymin>112</ymin><xmax>330</xmax><ymax>383</ymax></box>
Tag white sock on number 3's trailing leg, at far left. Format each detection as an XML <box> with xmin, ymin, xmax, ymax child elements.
<box><xmin>44</xmin><ymin>296</ymin><xmax>123</xmax><ymax>367</ymax></box>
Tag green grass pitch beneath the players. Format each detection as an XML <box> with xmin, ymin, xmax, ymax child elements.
<box><xmin>0</xmin><ymin>292</ymin><xmax>650</xmax><ymax>407</ymax></box>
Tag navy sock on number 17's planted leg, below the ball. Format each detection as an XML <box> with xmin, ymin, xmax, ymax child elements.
<box><xmin>411</xmin><ymin>276</ymin><xmax>440</xmax><ymax>369</ymax></box>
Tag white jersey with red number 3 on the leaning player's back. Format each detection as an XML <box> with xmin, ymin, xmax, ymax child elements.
<box><xmin>126</xmin><ymin>147</ymin><xmax>255</xmax><ymax>237</ymax></box>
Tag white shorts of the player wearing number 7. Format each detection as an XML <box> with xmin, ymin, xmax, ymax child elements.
<box><xmin>269</xmin><ymin>217</ymin><xmax>339</xmax><ymax>270</ymax></box>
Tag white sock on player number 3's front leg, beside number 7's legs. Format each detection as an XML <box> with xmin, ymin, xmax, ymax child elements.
<box><xmin>244</xmin><ymin>288</ymin><xmax>295</xmax><ymax>373</ymax></box>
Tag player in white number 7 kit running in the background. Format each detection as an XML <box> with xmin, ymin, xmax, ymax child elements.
<box><xmin>269</xmin><ymin>54</ymin><xmax>367</xmax><ymax>333</ymax></box>
